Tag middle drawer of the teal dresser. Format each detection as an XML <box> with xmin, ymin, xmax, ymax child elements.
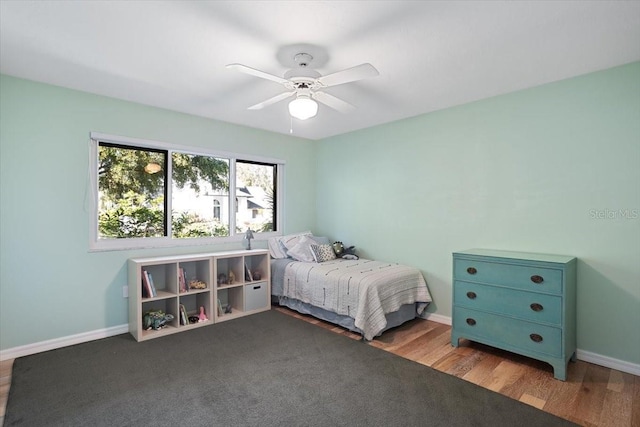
<box><xmin>453</xmin><ymin>281</ymin><xmax>562</xmax><ymax>326</ymax></box>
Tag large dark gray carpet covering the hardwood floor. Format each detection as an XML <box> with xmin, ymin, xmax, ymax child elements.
<box><xmin>5</xmin><ymin>311</ymin><xmax>574</xmax><ymax>427</ymax></box>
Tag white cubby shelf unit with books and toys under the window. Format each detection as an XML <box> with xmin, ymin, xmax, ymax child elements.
<box><xmin>128</xmin><ymin>249</ymin><xmax>271</xmax><ymax>341</ymax></box>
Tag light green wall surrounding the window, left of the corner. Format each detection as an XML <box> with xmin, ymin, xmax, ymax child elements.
<box><xmin>0</xmin><ymin>76</ymin><xmax>316</xmax><ymax>350</ymax></box>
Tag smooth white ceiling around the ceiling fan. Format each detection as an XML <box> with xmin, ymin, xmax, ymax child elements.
<box><xmin>0</xmin><ymin>0</ymin><xmax>640</xmax><ymax>139</ymax></box>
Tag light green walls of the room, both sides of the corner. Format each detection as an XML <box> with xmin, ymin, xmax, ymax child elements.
<box><xmin>0</xmin><ymin>63</ymin><xmax>640</xmax><ymax>364</ymax></box>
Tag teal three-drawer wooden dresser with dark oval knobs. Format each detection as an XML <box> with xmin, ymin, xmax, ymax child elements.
<box><xmin>451</xmin><ymin>249</ymin><xmax>576</xmax><ymax>381</ymax></box>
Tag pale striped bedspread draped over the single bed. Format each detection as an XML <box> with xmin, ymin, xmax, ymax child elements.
<box><xmin>282</xmin><ymin>259</ymin><xmax>431</xmax><ymax>340</ymax></box>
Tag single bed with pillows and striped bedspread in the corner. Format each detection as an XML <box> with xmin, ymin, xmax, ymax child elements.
<box><xmin>269</xmin><ymin>232</ymin><xmax>431</xmax><ymax>340</ymax></box>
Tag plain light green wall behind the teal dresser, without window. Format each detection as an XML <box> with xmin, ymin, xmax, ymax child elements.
<box><xmin>316</xmin><ymin>63</ymin><xmax>640</xmax><ymax>364</ymax></box>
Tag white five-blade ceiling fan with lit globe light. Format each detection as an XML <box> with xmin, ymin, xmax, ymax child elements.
<box><xmin>227</xmin><ymin>53</ymin><xmax>379</xmax><ymax>120</ymax></box>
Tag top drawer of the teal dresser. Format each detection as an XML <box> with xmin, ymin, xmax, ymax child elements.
<box><xmin>453</xmin><ymin>259</ymin><xmax>562</xmax><ymax>295</ymax></box>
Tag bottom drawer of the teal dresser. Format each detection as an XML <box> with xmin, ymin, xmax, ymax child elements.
<box><xmin>453</xmin><ymin>307</ymin><xmax>562</xmax><ymax>357</ymax></box>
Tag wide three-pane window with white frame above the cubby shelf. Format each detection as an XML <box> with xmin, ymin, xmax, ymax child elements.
<box><xmin>91</xmin><ymin>133</ymin><xmax>284</xmax><ymax>250</ymax></box>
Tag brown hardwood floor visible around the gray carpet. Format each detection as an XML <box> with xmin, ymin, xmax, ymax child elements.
<box><xmin>0</xmin><ymin>307</ymin><xmax>640</xmax><ymax>427</ymax></box>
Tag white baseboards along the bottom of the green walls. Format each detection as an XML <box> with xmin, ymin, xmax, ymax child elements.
<box><xmin>0</xmin><ymin>320</ymin><xmax>640</xmax><ymax>376</ymax></box>
